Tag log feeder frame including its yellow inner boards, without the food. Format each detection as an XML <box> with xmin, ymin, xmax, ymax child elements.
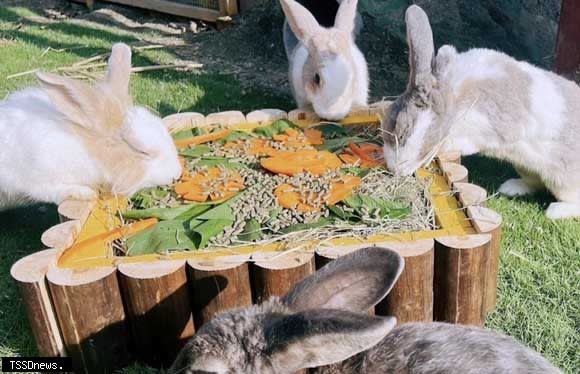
<box><xmin>12</xmin><ymin>104</ymin><xmax>501</xmax><ymax>373</ymax></box>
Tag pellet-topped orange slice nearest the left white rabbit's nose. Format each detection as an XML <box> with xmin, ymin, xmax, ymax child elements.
<box><xmin>174</xmin><ymin>167</ymin><xmax>244</xmax><ymax>203</ymax></box>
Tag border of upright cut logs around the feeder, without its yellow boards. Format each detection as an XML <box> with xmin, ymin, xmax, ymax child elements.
<box><xmin>12</xmin><ymin>104</ymin><xmax>502</xmax><ymax>372</ymax></box>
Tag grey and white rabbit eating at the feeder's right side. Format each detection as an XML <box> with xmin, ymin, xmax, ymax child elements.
<box><xmin>382</xmin><ymin>5</ymin><xmax>580</xmax><ymax>219</ymax></box>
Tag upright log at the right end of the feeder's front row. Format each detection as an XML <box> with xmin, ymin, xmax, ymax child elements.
<box><xmin>434</xmin><ymin>234</ymin><xmax>491</xmax><ymax>326</ymax></box>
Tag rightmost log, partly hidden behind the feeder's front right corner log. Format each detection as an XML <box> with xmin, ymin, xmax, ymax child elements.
<box><xmin>467</xmin><ymin>206</ymin><xmax>502</xmax><ymax>313</ymax></box>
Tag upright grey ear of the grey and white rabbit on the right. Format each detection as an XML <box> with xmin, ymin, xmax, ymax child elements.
<box><xmin>405</xmin><ymin>5</ymin><xmax>435</xmax><ymax>85</ymax></box>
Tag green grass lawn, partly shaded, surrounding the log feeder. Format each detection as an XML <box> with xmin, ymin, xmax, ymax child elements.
<box><xmin>0</xmin><ymin>2</ymin><xmax>580</xmax><ymax>373</ymax></box>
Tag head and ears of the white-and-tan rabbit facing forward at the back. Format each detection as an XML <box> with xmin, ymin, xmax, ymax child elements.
<box><xmin>280</xmin><ymin>0</ymin><xmax>369</xmax><ymax>121</ymax></box>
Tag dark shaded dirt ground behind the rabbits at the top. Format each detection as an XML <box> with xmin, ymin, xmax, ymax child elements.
<box><xmin>0</xmin><ymin>0</ymin><xmax>559</xmax><ymax>101</ymax></box>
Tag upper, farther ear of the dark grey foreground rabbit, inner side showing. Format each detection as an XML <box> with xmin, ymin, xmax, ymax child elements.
<box><xmin>283</xmin><ymin>247</ymin><xmax>404</xmax><ymax>312</ymax></box>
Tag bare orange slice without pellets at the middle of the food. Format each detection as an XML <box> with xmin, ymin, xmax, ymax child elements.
<box><xmin>260</xmin><ymin>149</ymin><xmax>342</xmax><ymax>176</ymax></box>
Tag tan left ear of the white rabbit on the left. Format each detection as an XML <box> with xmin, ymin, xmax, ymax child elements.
<box><xmin>36</xmin><ymin>73</ymin><xmax>102</xmax><ymax>128</ymax></box>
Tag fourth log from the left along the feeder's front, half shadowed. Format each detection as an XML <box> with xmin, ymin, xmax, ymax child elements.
<box><xmin>187</xmin><ymin>256</ymin><xmax>252</xmax><ymax>328</ymax></box>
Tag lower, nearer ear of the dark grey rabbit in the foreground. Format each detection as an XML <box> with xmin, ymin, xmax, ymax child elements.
<box><xmin>264</xmin><ymin>309</ymin><xmax>396</xmax><ymax>373</ymax></box>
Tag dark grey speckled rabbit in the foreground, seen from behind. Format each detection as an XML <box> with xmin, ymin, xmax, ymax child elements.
<box><xmin>169</xmin><ymin>247</ymin><xmax>560</xmax><ymax>374</ymax></box>
